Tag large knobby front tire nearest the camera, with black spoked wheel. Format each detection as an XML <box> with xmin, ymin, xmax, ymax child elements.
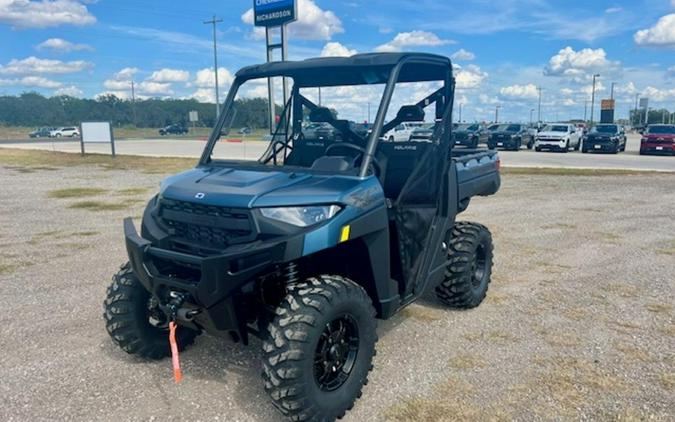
<box><xmin>262</xmin><ymin>275</ymin><xmax>377</xmax><ymax>421</ymax></box>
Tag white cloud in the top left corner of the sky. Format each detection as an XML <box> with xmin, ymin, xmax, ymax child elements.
<box><xmin>0</xmin><ymin>0</ymin><xmax>96</xmax><ymax>28</ymax></box>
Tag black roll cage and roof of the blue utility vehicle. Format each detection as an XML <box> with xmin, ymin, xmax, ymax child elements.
<box><xmin>199</xmin><ymin>53</ymin><xmax>455</xmax><ymax>177</ymax></box>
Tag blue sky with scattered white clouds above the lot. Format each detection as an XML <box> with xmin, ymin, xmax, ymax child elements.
<box><xmin>0</xmin><ymin>0</ymin><xmax>675</xmax><ymax>121</ymax></box>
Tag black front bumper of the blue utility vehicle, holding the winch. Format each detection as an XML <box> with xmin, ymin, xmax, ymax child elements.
<box><xmin>124</xmin><ymin>218</ymin><xmax>303</xmax><ymax>340</ymax></box>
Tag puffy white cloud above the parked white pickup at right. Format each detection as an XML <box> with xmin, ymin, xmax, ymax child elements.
<box><xmin>544</xmin><ymin>47</ymin><xmax>619</xmax><ymax>78</ymax></box>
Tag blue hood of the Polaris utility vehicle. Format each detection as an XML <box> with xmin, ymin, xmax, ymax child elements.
<box><xmin>160</xmin><ymin>167</ymin><xmax>368</xmax><ymax>208</ymax></box>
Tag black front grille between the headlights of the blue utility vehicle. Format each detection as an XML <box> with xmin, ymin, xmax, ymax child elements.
<box><xmin>159</xmin><ymin>199</ymin><xmax>255</xmax><ymax>248</ymax></box>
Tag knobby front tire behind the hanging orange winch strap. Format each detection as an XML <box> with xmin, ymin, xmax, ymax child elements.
<box><xmin>103</xmin><ymin>263</ymin><xmax>199</xmax><ymax>360</ymax></box>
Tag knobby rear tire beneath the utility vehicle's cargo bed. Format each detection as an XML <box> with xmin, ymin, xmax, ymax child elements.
<box><xmin>436</xmin><ymin>221</ymin><xmax>492</xmax><ymax>309</ymax></box>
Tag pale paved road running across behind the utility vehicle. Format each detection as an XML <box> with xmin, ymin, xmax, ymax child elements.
<box><xmin>0</xmin><ymin>135</ymin><xmax>675</xmax><ymax>172</ymax></box>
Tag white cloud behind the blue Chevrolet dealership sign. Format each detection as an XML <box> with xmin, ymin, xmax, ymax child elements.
<box><xmin>241</xmin><ymin>0</ymin><xmax>344</xmax><ymax>40</ymax></box>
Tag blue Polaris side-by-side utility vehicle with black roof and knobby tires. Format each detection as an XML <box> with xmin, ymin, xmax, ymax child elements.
<box><xmin>104</xmin><ymin>53</ymin><xmax>500</xmax><ymax>421</ymax></box>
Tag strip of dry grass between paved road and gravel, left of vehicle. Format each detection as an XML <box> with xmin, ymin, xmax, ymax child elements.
<box><xmin>0</xmin><ymin>148</ymin><xmax>197</xmax><ymax>174</ymax></box>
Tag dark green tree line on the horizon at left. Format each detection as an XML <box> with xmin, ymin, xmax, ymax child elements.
<box><xmin>0</xmin><ymin>92</ymin><xmax>280</xmax><ymax>128</ymax></box>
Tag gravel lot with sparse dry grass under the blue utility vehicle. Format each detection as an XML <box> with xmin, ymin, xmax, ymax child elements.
<box><xmin>0</xmin><ymin>151</ymin><xmax>675</xmax><ymax>421</ymax></box>
